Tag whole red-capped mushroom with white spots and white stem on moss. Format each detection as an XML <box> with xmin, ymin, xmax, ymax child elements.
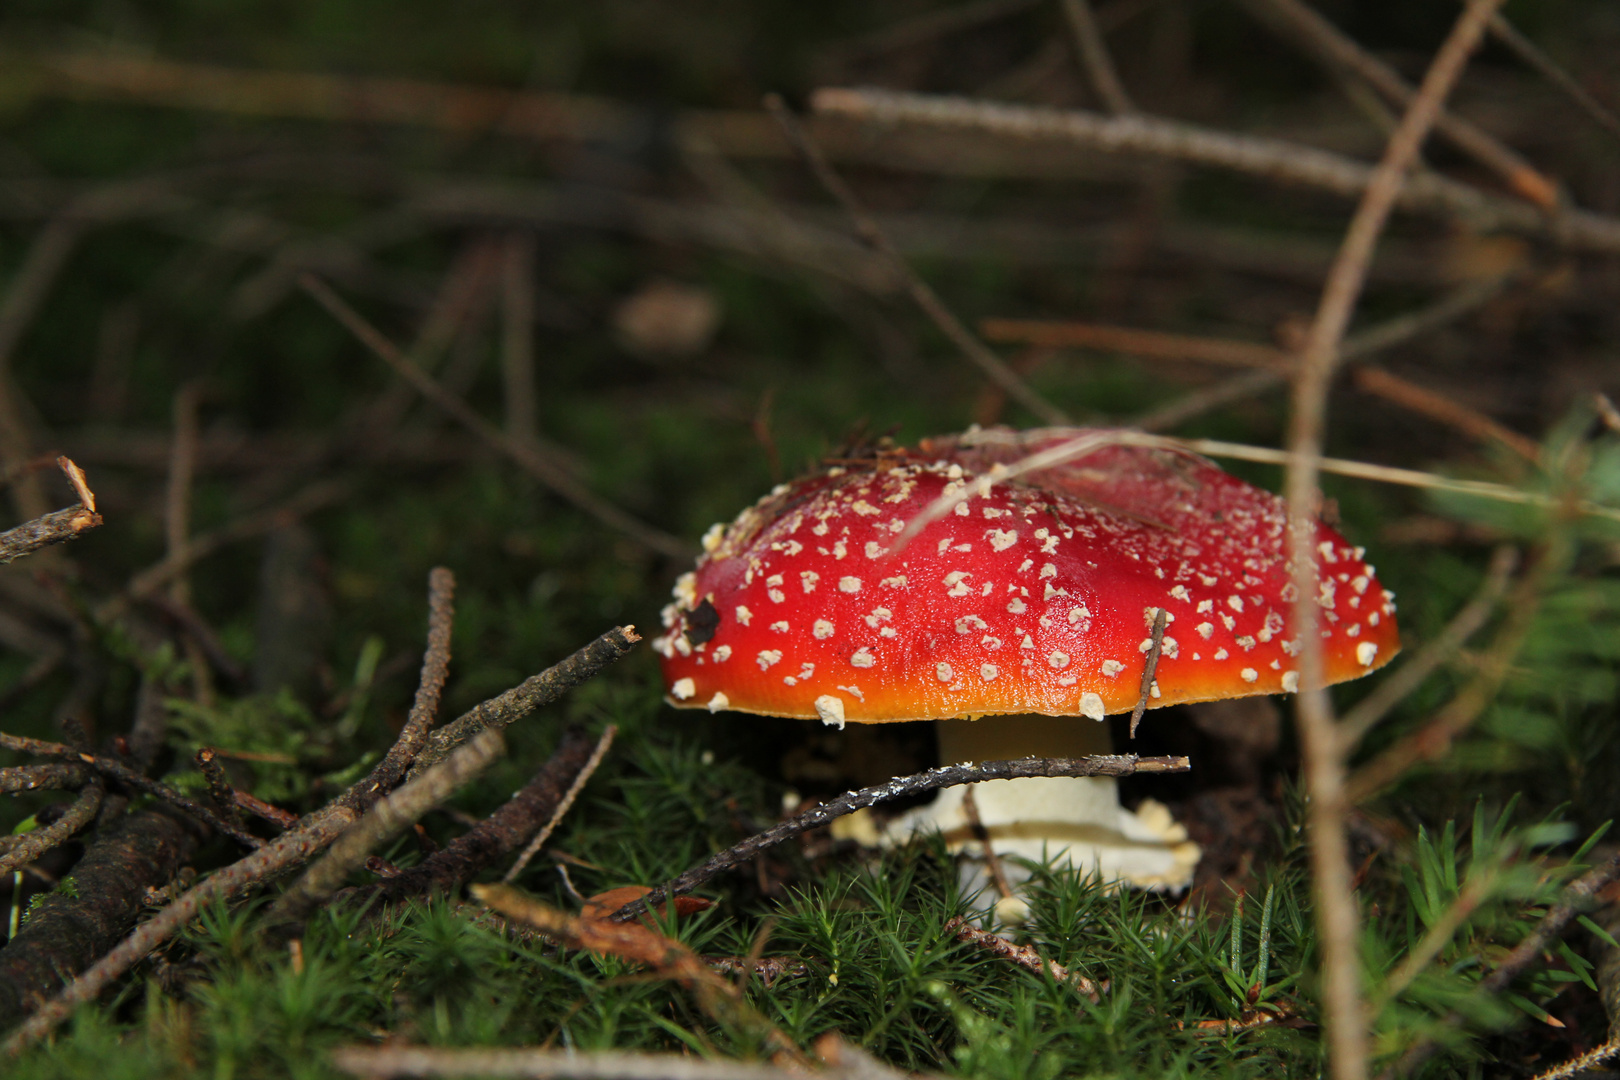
<box><xmin>654</xmin><ymin>429</ymin><xmax>1400</xmax><ymax>887</ymax></box>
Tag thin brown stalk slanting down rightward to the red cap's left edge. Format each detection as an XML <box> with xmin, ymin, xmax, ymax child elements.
<box><xmin>298</xmin><ymin>274</ymin><xmax>693</xmax><ymax>562</ymax></box>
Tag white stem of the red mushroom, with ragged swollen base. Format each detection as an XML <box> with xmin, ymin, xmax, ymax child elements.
<box><xmin>885</xmin><ymin>716</ymin><xmax>1199</xmax><ymax>906</ymax></box>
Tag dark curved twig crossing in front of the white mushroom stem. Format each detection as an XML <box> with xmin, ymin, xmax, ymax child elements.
<box><xmin>611</xmin><ymin>755</ymin><xmax>1192</xmax><ymax>923</ymax></box>
